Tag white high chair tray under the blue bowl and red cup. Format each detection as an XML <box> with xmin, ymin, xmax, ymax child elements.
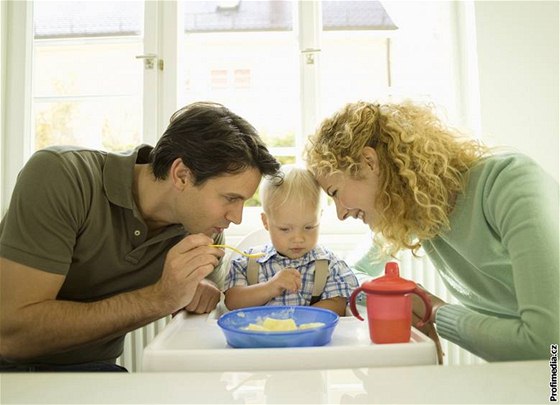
<box><xmin>142</xmin><ymin>306</ymin><xmax>437</xmax><ymax>371</ymax></box>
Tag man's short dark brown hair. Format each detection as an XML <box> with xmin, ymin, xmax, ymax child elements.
<box><xmin>150</xmin><ymin>102</ymin><xmax>280</xmax><ymax>185</ymax></box>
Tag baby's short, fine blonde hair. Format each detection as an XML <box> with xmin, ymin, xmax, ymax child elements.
<box><xmin>260</xmin><ymin>165</ymin><xmax>321</xmax><ymax>215</ymax></box>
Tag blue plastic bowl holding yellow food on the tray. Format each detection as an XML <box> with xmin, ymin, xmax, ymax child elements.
<box><xmin>218</xmin><ymin>306</ymin><xmax>338</xmax><ymax>348</ymax></box>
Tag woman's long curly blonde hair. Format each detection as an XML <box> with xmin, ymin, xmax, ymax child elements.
<box><xmin>305</xmin><ymin>101</ymin><xmax>488</xmax><ymax>255</ymax></box>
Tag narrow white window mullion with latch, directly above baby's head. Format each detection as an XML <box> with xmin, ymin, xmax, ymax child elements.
<box><xmin>296</xmin><ymin>1</ymin><xmax>322</xmax><ymax>163</ymax></box>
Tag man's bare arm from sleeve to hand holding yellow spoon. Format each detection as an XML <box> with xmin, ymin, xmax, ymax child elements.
<box><xmin>0</xmin><ymin>234</ymin><xmax>224</xmax><ymax>360</ymax></box>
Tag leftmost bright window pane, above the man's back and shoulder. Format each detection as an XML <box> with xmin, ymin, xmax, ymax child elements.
<box><xmin>33</xmin><ymin>1</ymin><xmax>143</xmax><ymax>151</ymax></box>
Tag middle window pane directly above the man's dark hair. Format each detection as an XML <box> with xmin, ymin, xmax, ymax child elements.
<box><xmin>180</xmin><ymin>1</ymin><xmax>300</xmax><ymax>154</ymax></box>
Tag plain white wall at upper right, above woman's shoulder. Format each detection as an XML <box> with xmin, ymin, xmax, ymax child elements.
<box><xmin>474</xmin><ymin>1</ymin><xmax>559</xmax><ymax>181</ymax></box>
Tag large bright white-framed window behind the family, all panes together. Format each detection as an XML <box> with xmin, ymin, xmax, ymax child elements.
<box><xmin>3</xmin><ymin>0</ymin><xmax>461</xmax><ymax>234</ymax></box>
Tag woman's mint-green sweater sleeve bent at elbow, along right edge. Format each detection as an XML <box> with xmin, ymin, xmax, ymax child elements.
<box><xmin>436</xmin><ymin>159</ymin><xmax>559</xmax><ymax>361</ymax></box>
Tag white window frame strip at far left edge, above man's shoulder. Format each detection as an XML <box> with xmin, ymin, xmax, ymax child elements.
<box><xmin>0</xmin><ymin>1</ymin><xmax>33</xmax><ymax>214</ymax></box>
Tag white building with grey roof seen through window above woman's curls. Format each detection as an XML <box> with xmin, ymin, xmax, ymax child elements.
<box><xmin>320</xmin><ymin>1</ymin><xmax>397</xmax><ymax>115</ymax></box>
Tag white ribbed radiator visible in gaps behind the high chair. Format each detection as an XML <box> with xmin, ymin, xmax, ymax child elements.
<box><xmin>117</xmin><ymin>253</ymin><xmax>484</xmax><ymax>371</ymax></box>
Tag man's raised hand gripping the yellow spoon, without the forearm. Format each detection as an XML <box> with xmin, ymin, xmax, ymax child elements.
<box><xmin>155</xmin><ymin>234</ymin><xmax>224</xmax><ymax>313</ymax></box>
